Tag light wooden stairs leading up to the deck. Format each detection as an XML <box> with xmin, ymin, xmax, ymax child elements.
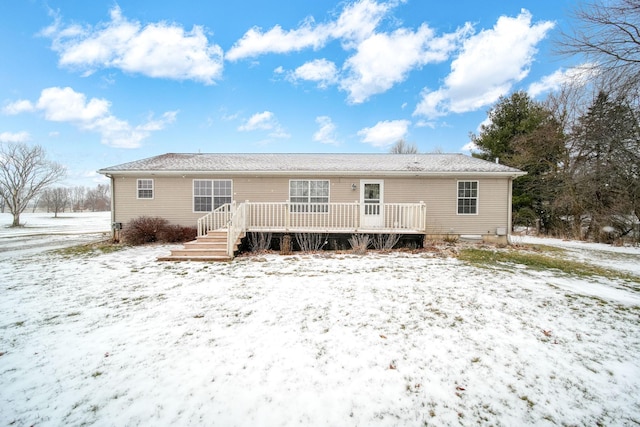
<box><xmin>158</xmin><ymin>230</ymin><xmax>244</xmax><ymax>261</ymax></box>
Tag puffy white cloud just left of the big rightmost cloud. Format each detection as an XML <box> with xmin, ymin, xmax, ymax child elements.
<box><xmin>340</xmin><ymin>24</ymin><xmax>471</xmax><ymax>104</ymax></box>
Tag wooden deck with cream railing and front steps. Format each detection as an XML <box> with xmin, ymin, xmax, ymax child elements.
<box><xmin>158</xmin><ymin>202</ymin><xmax>426</xmax><ymax>261</ymax></box>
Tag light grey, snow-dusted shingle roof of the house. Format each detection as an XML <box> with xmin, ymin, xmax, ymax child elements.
<box><xmin>98</xmin><ymin>153</ymin><xmax>523</xmax><ymax>176</ymax></box>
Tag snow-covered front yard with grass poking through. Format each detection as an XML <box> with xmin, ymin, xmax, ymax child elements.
<box><xmin>0</xmin><ymin>214</ymin><xmax>640</xmax><ymax>426</ymax></box>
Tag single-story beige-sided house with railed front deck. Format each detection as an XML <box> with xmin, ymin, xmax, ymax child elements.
<box><xmin>98</xmin><ymin>153</ymin><xmax>524</xmax><ymax>255</ymax></box>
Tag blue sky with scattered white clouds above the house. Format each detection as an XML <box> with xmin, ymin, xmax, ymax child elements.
<box><xmin>0</xmin><ymin>0</ymin><xmax>578</xmax><ymax>186</ymax></box>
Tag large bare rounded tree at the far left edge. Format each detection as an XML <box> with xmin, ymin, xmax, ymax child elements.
<box><xmin>0</xmin><ymin>143</ymin><xmax>65</xmax><ymax>227</ymax></box>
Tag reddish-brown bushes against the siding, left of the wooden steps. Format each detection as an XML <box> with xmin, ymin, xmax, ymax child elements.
<box><xmin>122</xmin><ymin>216</ymin><xmax>197</xmax><ymax>245</ymax></box>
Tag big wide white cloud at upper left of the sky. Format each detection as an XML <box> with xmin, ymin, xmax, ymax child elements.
<box><xmin>42</xmin><ymin>6</ymin><xmax>223</xmax><ymax>84</ymax></box>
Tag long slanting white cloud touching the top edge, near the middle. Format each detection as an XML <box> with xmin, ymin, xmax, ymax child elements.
<box><xmin>225</xmin><ymin>0</ymin><xmax>390</xmax><ymax>61</ymax></box>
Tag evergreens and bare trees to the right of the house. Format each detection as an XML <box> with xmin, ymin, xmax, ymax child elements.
<box><xmin>470</xmin><ymin>0</ymin><xmax>640</xmax><ymax>242</ymax></box>
